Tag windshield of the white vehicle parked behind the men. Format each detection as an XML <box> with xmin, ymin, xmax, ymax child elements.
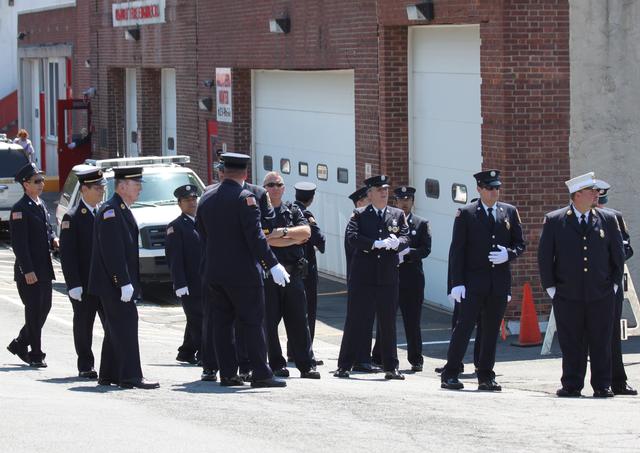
<box><xmin>106</xmin><ymin>173</ymin><xmax>203</xmax><ymax>207</ymax></box>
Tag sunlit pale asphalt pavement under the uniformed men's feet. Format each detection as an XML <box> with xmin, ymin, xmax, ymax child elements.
<box><xmin>0</xmin><ymin>199</ymin><xmax>640</xmax><ymax>452</ymax></box>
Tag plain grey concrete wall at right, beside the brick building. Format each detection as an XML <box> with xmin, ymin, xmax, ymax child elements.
<box><xmin>570</xmin><ymin>0</ymin><xmax>640</xmax><ymax>286</ymax></box>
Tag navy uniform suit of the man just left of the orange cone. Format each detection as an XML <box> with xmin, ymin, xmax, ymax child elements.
<box><xmin>441</xmin><ymin>200</ymin><xmax>525</xmax><ymax>382</ymax></box>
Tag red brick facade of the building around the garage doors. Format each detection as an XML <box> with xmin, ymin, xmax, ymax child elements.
<box><xmin>20</xmin><ymin>0</ymin><xmax>570</xmax><ymax>317</ymax></box>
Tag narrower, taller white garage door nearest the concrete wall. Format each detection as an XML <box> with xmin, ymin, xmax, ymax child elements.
<box><xmin>409</xmin><ymin>26</ymin><xmax>482</xmax><ymax>308</ymax></box>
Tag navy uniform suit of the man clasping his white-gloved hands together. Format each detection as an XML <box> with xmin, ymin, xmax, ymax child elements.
<box><xmin>338</xmin><ymin>205</ymin><xmax>409</xmax><ymax>371</ymax></box>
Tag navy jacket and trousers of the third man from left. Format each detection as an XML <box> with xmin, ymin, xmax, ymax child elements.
<box><xmin>89</xmin><ymin>193</ymin><xmax>142</xmax><ymax>382</ymax></box>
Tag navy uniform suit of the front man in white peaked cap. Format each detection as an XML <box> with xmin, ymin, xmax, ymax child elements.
<box><xmin>538</xmin><ymin>206</ymin><xmax>624</xmax><ymax>390</ymax></box>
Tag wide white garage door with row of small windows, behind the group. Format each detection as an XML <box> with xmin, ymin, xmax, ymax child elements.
<box><xmin>252</xmin><ymin>71</ymin><xmax>356</xmax><ymax>277</ymax></box>
